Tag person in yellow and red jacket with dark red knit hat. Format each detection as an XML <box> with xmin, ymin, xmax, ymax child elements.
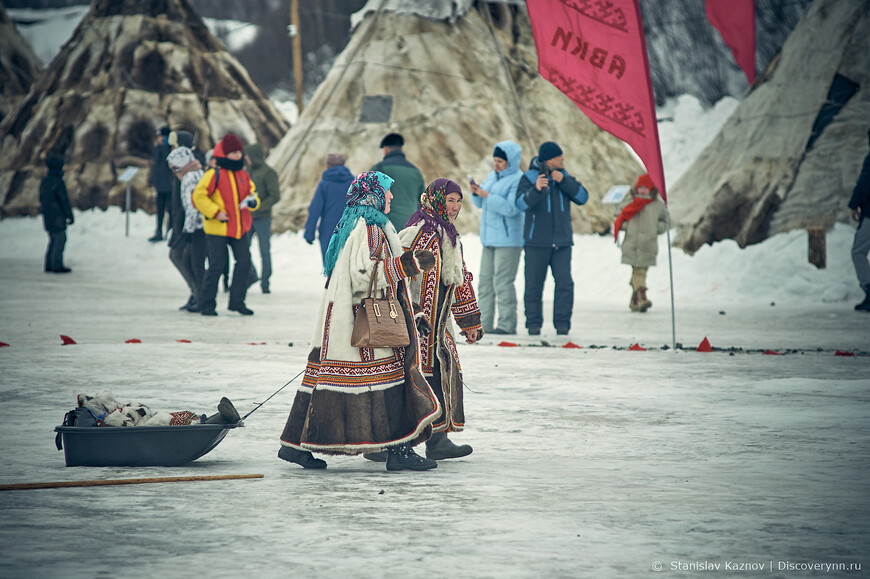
<box><xmin>193</xmin><ymin>133</ymin><xmax>260</xmax><ymax>316</ymax></box>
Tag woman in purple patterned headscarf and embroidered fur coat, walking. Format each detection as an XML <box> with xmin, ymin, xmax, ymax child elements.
<box><xmin>399</xmin><ymin>179</ymin><xmax>483</xmax><ymax>460</ymax></box>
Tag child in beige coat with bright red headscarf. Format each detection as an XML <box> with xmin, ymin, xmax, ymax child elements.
<box><xmin>613</xmin><ymin>173</ymin><xmax>667</xmax><ymax>312</ymax></box>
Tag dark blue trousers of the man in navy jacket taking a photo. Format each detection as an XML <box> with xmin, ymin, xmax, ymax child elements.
<box><xmin>523</xmin><ymin>245</ymin><xmax>574</xmax><ymax>330</ymax></box>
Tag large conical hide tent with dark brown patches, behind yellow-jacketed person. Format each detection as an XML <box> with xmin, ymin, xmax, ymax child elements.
<box><xmin>0</xmin><ymin>0</ymin><xmax>288</xmax><ymax>215</ymax></box>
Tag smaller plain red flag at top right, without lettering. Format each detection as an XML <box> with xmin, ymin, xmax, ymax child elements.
<box><xmin>705</xmin><ymin>0</ymin><xmax>755</xmax><ymax>84</ymax></box>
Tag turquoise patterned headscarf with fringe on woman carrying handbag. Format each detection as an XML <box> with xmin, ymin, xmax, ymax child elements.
<box><xmin>323</xmin><ymin>171</ymin><xmax>393</xmax><ymax>277</ymax></box>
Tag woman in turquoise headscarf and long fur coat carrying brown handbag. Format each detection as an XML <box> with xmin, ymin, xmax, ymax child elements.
<box><xmin>278</xmin><ymin>171</ymin><xmax>441</xmax><ymax>470</ymax></box>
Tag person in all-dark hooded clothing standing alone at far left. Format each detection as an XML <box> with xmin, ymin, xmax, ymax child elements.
<box><xmin>39</xmin><ymin>155</ymin><xmax>75</xmax><ymax>273</ymax></box>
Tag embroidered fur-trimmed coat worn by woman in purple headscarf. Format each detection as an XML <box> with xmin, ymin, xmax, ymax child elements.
<box><xmin>399</xmin><ymin>222</ymin><xmax>482</xmax><ymax>432</ymax></box>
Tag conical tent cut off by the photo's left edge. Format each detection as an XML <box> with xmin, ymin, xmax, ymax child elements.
<box><xmin>0</xmin><ymin>4</ymin><xmax>42</xmax><ymax>121</ymax></box>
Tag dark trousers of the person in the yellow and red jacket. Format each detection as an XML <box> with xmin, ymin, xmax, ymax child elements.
<box><xmin>196</xmin><ymin>235</ymin><xmax>251</xmax><ymax>312</ymax></box>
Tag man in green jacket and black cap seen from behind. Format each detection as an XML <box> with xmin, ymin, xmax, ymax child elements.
<box><xmin>371</xmin><ymin>133</ymin><xmax>426</xmax><ymax>231</ymax></box>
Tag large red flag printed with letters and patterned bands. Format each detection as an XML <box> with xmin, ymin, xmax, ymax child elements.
<box><xmin>526</xmin><ymin>0</ymin><xmax>667</xmax><ymax>202</ymax></box>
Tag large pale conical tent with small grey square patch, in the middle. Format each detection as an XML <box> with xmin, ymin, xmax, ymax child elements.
<box><xmin>269</xmin><ymin>3</ymin><xmax>643</xmax><ymax>233</ymax></box>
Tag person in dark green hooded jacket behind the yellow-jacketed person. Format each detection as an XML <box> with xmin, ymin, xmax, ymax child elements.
<box><xmin>245</xmin><ymin>143</ymin><xmax>281</xmax><ymax>294</ymax></box>
